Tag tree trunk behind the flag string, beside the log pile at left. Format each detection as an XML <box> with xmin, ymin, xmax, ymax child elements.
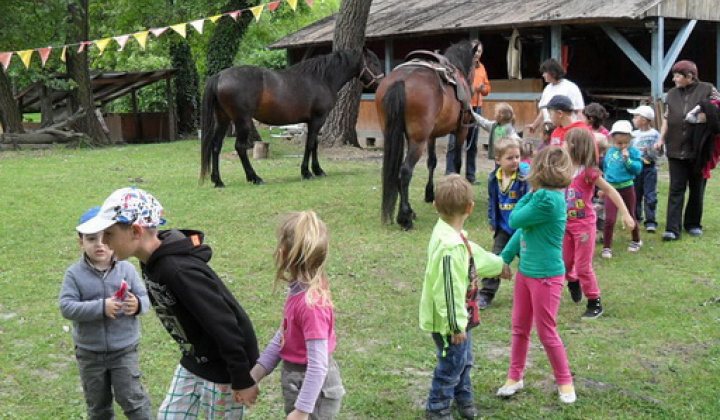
<box><xmin>66</xmin><ymin>0</ymin><xmax>110</xmax><ymax>146</ymax></box>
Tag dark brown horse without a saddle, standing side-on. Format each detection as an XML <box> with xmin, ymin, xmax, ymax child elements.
<box><xmin>200</xmin><ymin>49</ymin><xmax>383</xmax><ymax>187</ymax></box>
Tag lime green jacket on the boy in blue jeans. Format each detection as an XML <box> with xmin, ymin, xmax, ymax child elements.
<box><xmin>420</xmin><ymin>219</ymin><xmax>503</xmax><ymax>335</ymax></box>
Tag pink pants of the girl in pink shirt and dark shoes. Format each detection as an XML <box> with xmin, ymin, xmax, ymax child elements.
<box><xmin>563</xmin><ymin>220</ymin><xmax>600</xmax><ymax>299</ymax></box>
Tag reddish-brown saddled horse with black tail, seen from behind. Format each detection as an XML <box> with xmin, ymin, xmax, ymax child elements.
<box><xmin>375</xmin><ymin>41</ymin><xmax>476</xmax><ymax>230</ymax></box>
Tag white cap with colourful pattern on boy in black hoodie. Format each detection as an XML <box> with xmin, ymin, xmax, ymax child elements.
<box><xmin>75</xmin><ymin>187</ymin><xmax>165</xmax><ymax>234</ymax></box>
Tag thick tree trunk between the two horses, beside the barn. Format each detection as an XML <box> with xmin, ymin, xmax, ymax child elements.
<box><xmin>321</xmin><ymin>0</ymin><xmax>372</xmax><ymax>147</ymax></box>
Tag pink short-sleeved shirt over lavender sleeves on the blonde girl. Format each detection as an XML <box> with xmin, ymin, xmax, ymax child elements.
<box><xmin>280</xmin><ymin>291</ymin><xmax>336</xmax><ymax>365</ymax></box>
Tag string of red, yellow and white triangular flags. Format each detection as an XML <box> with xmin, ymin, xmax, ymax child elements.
<box><xmin>0</xmin><ymin>0</ymin><xmax>313</xmax><ymax>71</ymax></box>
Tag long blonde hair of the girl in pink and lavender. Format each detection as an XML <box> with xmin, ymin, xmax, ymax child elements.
<box><xmin>275</xmin><ymin>210</ymin><xmax>332</xmax><ymax>306</ymax></box>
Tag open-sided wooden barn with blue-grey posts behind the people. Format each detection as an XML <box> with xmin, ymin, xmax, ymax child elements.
<box><xmin>270</xmin><ymin>0</ymin><xmax>720</xmax><ymax>141</ymax></box>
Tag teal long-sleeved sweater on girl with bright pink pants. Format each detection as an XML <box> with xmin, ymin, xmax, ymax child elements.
<box><xmin>500</xmin><ymin>189</ymin><xmax>567</xmax><ymax>278</ymax></box>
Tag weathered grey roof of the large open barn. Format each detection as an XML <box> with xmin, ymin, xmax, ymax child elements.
<box><xmin>270</xmin><ymin>0</ymin><xmax>720</xmax><ymax>49</ymax></box>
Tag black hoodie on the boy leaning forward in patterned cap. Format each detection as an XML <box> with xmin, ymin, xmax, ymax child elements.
<box><xmin>141</xmin><ymin>229</ymin><xmax>259</xmax><ymax>389</ymax></box>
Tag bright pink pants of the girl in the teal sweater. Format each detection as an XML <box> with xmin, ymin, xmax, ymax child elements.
<box><xmin>508</xmin><ymin>272</ymin><xmax>572</xmax><ymax>386</ymax></box>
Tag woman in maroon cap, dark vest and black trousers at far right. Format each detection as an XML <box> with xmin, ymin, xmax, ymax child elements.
<box><xmin>656</xmin><ymin>60</ymin><xmax>720</xmax><ymax>241</ymax></box>
